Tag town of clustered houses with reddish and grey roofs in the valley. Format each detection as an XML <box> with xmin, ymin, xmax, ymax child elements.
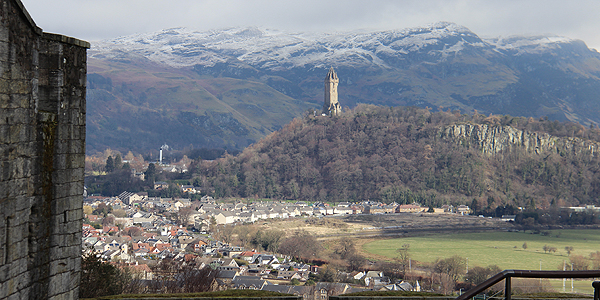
<box><xmin>82</xmin><ymin>182</ymin><xmax>476</xmax><ymax>299</ymax></box>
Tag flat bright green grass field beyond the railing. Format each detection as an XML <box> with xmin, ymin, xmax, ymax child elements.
<box><xmin>363</xmin><ymin>230</ymin><xmax>600</xmax><ymax>270</ymax></box>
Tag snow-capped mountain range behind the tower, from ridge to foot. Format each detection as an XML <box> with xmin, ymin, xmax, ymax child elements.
<box><xmin>88</xmin><ymin>23</ymin><xmax>600</xmax><ymax>152</ymax></box>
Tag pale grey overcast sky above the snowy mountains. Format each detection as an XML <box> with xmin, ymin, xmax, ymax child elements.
<box><xmin>21</xmin><ymin>0</ymin><xmax>600</xmax><ymax>50</ymax></box>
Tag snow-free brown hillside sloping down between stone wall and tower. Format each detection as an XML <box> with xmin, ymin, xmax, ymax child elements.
<box><xmin>86</xmin><ymin>59</ymin><xmax>309</xmax><ymax>153</ymax></box>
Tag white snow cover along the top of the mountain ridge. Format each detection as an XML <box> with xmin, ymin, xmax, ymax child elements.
<box><xmin>88</xmin><ymin>22</ymin><xmax>571</xmax><ymax>70</ymax></box>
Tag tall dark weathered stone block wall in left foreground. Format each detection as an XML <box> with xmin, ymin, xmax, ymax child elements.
<box><xmin>0</xmin><ymin>0</ymin><xmax>89</xmax><ymax>299</ymax></box>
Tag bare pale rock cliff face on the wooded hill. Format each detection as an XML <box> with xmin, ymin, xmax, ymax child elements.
<box><xmin>440</xmin><ymin>124</ymin><xmax>600</xmax><ymax>156</ymax></box>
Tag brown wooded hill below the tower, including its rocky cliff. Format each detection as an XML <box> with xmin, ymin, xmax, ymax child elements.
<box><xmin>197</xmin><ymin>105</ymin><xmax>600</xmax><ymax>210</ymax></box>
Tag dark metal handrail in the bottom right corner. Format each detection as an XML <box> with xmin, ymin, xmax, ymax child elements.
<box><xmin>455</xmin><ymin>270</ymin><xmax>600</xmax><ymax>300</ymax></box>
